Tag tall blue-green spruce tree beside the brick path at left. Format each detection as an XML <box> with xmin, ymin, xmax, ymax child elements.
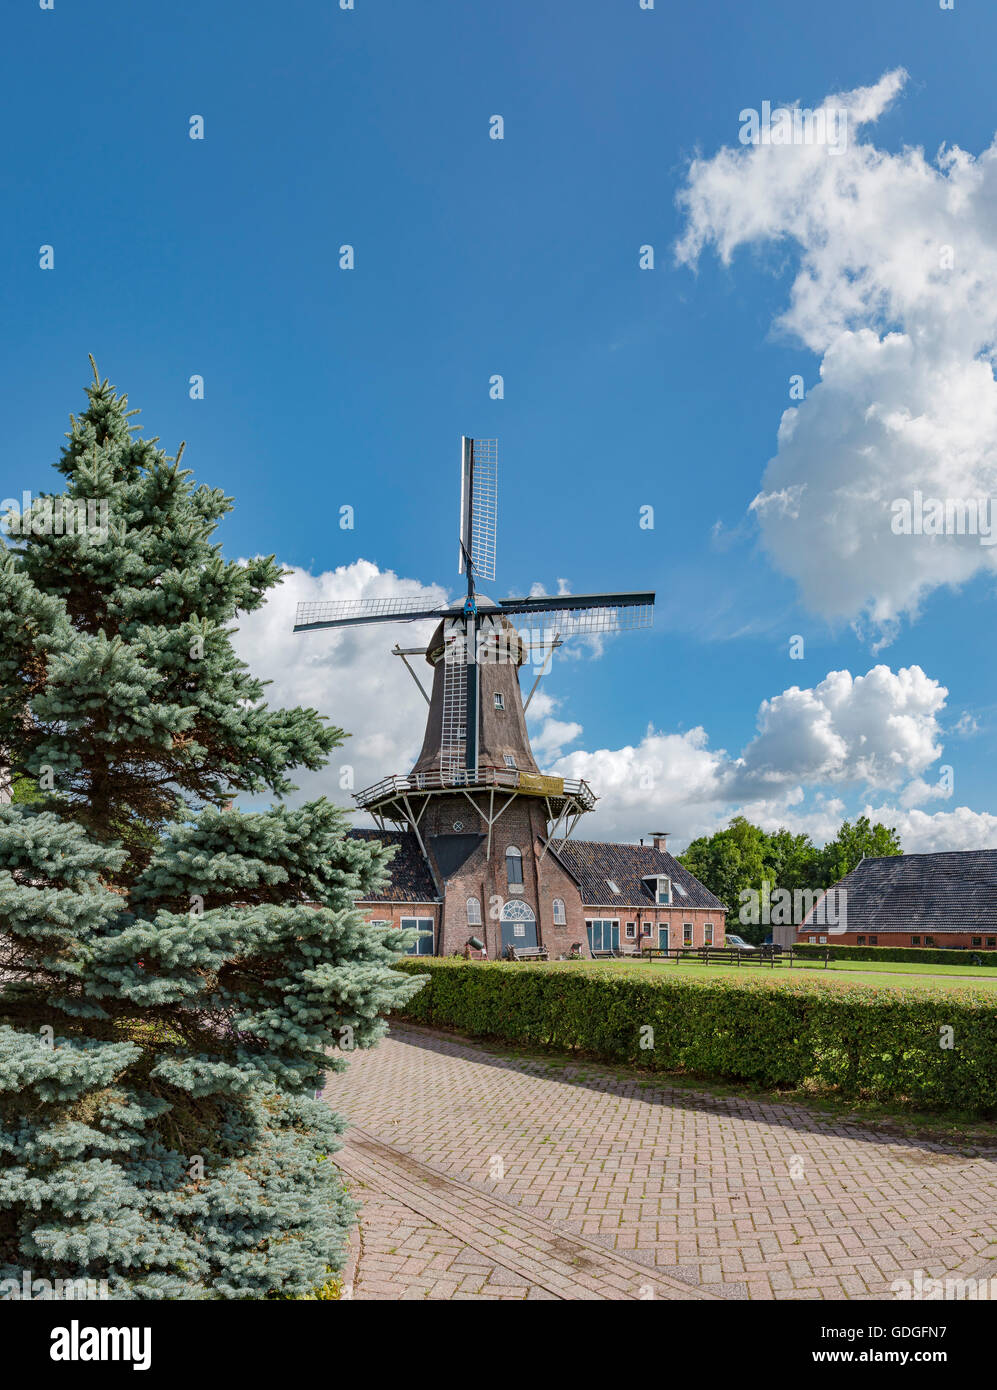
<box><xmin>0</xmin><ymin>370</ymin><xmax>420</xmax><ymax>1298</ymax></box>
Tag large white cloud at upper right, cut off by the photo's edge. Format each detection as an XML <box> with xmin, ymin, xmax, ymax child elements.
<box><xmin>677</xmin><ymin>70</ymin><xmax>997</xmax><ymax>642</ymax></box>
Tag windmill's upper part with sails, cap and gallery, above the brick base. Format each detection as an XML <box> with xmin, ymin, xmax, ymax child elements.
<box><xmin>295</xmin><ymin>436</ymin><xmax>655</xmax><ymax>845</ymax></box>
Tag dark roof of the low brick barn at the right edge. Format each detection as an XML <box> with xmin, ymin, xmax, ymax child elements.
<box><xmin>800</xmin><ymin>849</ymin><xmax>997</xmax><ymax>931</ymax></box>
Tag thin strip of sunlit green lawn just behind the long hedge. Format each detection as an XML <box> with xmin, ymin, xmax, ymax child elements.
<box><xmin>585</xmin><ymin>960</ymin><xmax>997</xmax><ymax>992</ymax></box>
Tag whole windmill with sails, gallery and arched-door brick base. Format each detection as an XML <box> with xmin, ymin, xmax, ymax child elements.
<box><xmin>295</xmin><ymin>438</ymin><xmax>655</xmax><ymax>958</ymax></box>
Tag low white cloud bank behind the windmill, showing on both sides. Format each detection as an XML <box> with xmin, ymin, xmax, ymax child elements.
<box><xmin>235</xmin><ymin>560</ymin><xmax>997</xmax><ymax>849</ymax></box>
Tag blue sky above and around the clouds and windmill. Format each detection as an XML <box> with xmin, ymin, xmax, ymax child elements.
<box><xmin>0</xmin><ymin>0</ymin><xmax>997</xmax><ymax>848</ymax></box>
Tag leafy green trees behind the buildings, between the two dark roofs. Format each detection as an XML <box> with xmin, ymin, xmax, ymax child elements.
<box><xmin>679</xmin><ymin>816</ymin><xmax>902</xmax><ymax>942</ymax></box>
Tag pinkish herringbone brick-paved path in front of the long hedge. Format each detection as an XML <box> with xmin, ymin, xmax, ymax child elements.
<box><xmin>325</xmin><ymin>1024</ymin><xmax>997</xmax><ymax>1300</ymax></box>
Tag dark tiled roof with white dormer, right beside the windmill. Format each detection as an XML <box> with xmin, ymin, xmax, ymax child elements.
<box><xmin>552</xmin><ymin>840</ymin><xmax>723</xmax><ymax>912</ymax></box>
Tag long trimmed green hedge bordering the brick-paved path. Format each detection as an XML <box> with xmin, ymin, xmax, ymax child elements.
<box><xmin>398</xmin><ymin>956</ymin><xmax>997</xmax><ymax>1115</ymax></box>
